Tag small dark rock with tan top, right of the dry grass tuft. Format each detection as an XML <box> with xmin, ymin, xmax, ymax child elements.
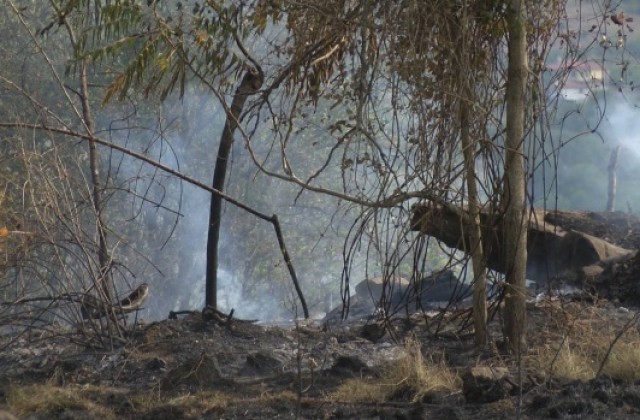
<box><xmin>462</xmin><ymin>366</ymin><xmax>512</xmax><ymax>403</ymax></box>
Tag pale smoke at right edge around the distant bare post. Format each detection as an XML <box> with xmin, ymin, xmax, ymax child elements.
<box><xmin>534</xmin><ymin>95</ymin><xmax>640</xmax><ymax>213</ymax></box>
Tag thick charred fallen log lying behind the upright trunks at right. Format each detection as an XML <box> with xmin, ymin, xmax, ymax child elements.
<box><xmin>411</xmin><ymin>204</ymin><xmax>640</xmax><ymax>286</ymax></box>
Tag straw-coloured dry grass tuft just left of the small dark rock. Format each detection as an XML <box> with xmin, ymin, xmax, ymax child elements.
<box><xmin>328</xmin><ymin>339</ymin><xmax>461</xmax><ymax>402</ymax></box>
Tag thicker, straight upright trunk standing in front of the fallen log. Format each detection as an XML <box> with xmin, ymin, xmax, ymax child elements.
<box><xmin>503</xmin><ymin>0</ymin><xmax>528</xmax><ymax>354</ymax></box>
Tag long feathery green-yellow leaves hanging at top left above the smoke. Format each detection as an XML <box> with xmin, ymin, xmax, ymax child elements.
<box><xmin>63</xmin><ymin>0</ymin><xmax>240</xmax><ymax>102</ymax></box>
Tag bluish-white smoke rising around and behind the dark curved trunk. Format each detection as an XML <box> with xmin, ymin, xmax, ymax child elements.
<box><xmin>105</xmin><ymin>91</ymin><xmax>352</xmax><ymax>321</ymax></box>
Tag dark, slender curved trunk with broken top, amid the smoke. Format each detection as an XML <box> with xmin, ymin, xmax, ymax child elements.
<box><xmin>205</xmin><ymin>68</ymin><xmax>263</xmax><ymax>309</ymax></box>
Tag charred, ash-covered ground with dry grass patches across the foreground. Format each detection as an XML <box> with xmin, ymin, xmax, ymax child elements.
<box><xmin>0</xmin><ymin>298</ymin><xmax>640</xmax><ymax>419</ymax></box>
